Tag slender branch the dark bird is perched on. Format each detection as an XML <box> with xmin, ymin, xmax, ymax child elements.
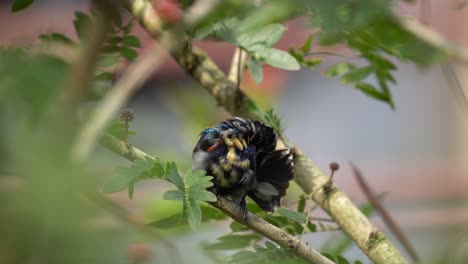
<box><xmin>101</xmin><ymin>134</ymin><xmax>333</xmax><ymax>264</ymax></box>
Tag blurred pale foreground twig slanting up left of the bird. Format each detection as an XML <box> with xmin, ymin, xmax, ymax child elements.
<box><xmin>73</xmin><ymin>45</ymin><xmax>164</xmax><ymax>160</ymax></box>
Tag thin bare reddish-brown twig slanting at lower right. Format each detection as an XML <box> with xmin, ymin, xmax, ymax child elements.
<box><xmin>350</xmin><ymin>162</ymin><xmax>419</xmax><ymax>262</ymax></box>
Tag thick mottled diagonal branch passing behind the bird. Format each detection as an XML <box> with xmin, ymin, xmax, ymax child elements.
<box><xmin>123</xmin><ymin>0</ymin><xmax>408</xmax><ymax>264</ymax></box>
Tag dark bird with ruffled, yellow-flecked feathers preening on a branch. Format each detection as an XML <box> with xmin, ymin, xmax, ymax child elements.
<box><xmin>192</xmin><ymin>117</ymin><xmax>294</xmax><ymax>213</ymax></box>
